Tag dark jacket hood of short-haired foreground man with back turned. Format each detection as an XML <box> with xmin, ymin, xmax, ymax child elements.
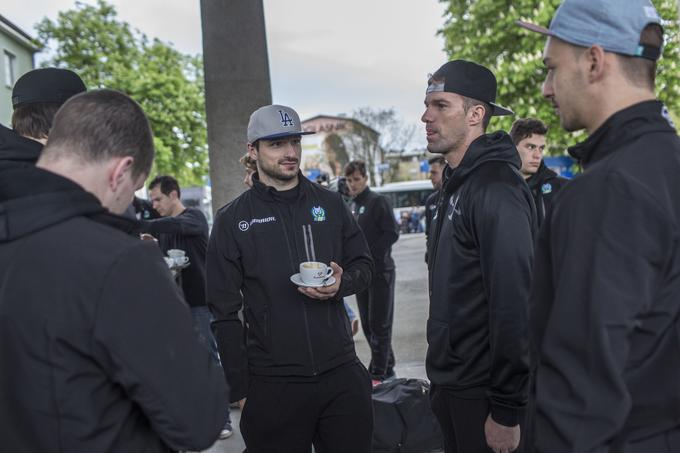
<box><xmin>0</xmin><ymin>165</ymin><xmax>138</xmax><ymax>243</ymax></box>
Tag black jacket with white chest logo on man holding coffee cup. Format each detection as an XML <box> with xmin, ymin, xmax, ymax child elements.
<box><xmin>207</xmin><ymin>173</ymin><xmax>373</xmax><ymax>401</ymax></box>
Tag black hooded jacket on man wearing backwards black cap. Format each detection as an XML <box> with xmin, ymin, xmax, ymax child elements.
<box><xmin>426</xmin><ymin>132</ymin><xmax>536</xmax><ymax>426</ymax></box>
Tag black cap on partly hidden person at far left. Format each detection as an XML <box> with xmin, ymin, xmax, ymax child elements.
<box><xmin>12</xmin><ymin>68</ymin><xmax>87</xmax><ymax>109</ymax></box>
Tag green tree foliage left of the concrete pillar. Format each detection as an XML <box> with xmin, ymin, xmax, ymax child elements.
<box><xmin>36</xmin><ymin>0</ymin><xmax>208</xmax><ymax>186</ymax></box>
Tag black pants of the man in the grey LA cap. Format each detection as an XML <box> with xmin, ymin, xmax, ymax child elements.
<box><xmin>240</xmin><ymin>361</ymin><xmax>373</xmax><ymax>453</ymax></box>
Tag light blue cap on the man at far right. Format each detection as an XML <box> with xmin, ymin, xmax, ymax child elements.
<box><xmin>517</xmin><ymin>0</ymin><xmax>662</xmax><ymax>60</ymax></box>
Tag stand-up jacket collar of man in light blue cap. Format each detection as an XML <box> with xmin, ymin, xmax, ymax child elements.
<box><xmin>569</xmin><ymin>101</ymin><xmax>675</xmax><ymax>169</ymax></box>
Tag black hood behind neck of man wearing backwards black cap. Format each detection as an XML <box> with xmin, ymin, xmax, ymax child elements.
<box><xmin>444</xmin><ymin>131</ymin><xmax>522</xmax><ymax>193</ymax></box>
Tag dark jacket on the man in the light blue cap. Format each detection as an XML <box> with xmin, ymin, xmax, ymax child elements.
<box><xmin>530</xmin><ymin>101</ymin><xmax>680</xmax><ymax>453</ymax></box>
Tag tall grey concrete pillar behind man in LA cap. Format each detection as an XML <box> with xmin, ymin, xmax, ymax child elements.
<box><xmin>201</xmin><ymin>0</ymin><xmax>272</xmax><ymax>212</ymax></box>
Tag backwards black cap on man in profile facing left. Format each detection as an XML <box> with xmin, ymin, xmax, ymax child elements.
<box><xmin>426</xmin><ymin>60</ymin><xmax>515</xmax><ymax>116</ymax></box>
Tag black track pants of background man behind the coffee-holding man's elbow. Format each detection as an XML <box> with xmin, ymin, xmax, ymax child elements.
<box><xmin>357</xmin><ymin>269</ymin><xmax>395</xmax><ymax>379</ymax></box>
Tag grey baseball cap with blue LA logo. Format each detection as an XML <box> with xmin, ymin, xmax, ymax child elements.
<box><xmin>248</xmin><ymin>105</ymin><xmax>314</xmax><ymax>143</ymax></box>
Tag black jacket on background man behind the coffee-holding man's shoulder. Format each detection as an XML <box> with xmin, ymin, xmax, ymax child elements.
<box><xmin>354</xmin><ymin>187</ymin><xmax>399</xmax><ymax>273</ymax></box>
